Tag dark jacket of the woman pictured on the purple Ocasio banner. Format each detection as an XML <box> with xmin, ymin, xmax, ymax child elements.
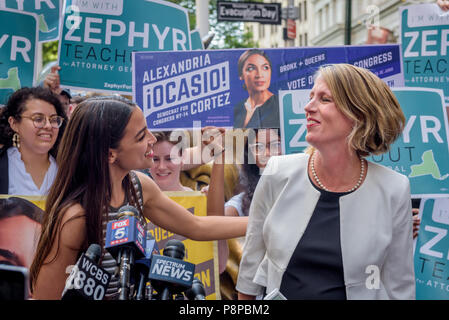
<box><xmin>234</xmin><ymin>94</ymin><xmax>280</xmax><ymax>128</ymax></box>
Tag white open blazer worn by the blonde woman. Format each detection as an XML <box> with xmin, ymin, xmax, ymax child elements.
<box><xmin>236</xmin><ymin>154</ymin><xmax>415</xmax><ymax>299</ymax></box>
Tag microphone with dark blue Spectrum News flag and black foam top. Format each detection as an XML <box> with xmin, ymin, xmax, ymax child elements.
<box><xmin>148</xmin><ymin>239</ymin><xmax>195</xmax><ymax>300</ymax></box>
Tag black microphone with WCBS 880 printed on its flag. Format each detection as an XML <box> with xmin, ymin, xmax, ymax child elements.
<box><xmin>61</xmin><ymin>243</ymin><xmax>111</xmax><ymax>300</ymax></box>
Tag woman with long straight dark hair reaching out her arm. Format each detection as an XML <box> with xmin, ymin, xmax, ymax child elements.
<box><xmin>30</xmin><ymin>96</ymin><xmax>247</xmax><ymax>299</ymax></box>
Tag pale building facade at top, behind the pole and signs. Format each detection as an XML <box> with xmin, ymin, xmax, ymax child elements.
<box><xmin>245</xmin><ymin>0</ymin><xmax>435</xmax><ymax>48</ymax></box>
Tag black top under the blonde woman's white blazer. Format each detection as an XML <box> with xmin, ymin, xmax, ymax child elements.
<box><xmin>280</xmin><ymin>178</ymin><xmax>348</xmax><ymax>300</ymax></box>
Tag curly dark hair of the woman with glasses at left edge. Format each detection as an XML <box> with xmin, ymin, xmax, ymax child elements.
<box><xmin>0</xmin><ymin>87</ymin><xmax>67</xmax><ymax>158</ymax></box>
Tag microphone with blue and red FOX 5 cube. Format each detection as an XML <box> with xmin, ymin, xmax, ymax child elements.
<box><xmin>105</xmin><ymin>205</ymin><xmax>145</xmax><ymax>300</ymax></box>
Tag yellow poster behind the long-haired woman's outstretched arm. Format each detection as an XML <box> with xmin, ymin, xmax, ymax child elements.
<box><xmin>147</xmin><ymin>191</ymin><xmax>221</xmax><ymax>300</ymax></box>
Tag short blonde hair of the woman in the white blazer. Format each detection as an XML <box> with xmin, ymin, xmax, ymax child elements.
<box><xmin>318</xmin><ymin>64</ymin><xmax>405</xmax><ymax>156</ymax></box>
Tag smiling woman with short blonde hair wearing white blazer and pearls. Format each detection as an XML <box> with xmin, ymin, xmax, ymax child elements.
<box><xmin>237</xmin><ymin>64</ymin><xmax>415</xmax><ymax>300</ymax></box>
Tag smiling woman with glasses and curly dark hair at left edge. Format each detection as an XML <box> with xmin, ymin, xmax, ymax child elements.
<box><xmin>0</xmin><ymin>87</ymin><xmax>67</xmax><ymax>196</ymax></box>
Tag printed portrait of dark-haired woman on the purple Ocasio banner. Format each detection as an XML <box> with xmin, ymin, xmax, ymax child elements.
<box><xmin>234</xmin><ymin>49</ymin><xmax>279</xmax><ymax>128</ymax></box>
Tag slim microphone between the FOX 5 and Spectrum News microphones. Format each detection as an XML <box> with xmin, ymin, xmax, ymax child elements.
<box><xmin>132</xmin><ymin>232</ymin><xmax>159</xmax><ymax>300</ymax></box>
